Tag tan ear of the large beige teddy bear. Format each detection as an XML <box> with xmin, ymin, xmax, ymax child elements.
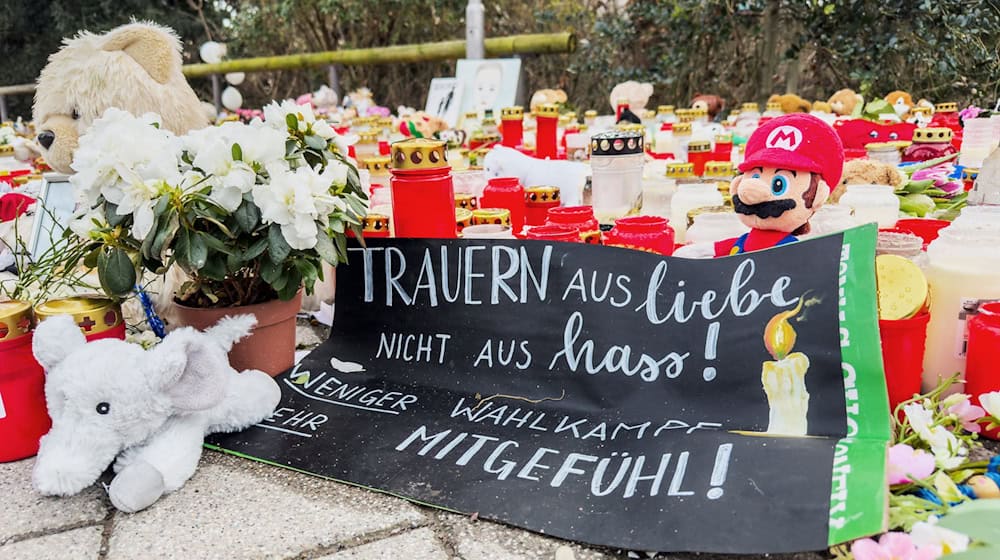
<box><xmin>104</xmin><ymin>23</ymin><xmax>180</xmax><ymax>84</ymax></box>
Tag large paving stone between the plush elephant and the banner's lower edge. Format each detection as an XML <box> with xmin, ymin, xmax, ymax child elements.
<box><xmin>107</xmin><ymin>452</ymin><xmax>426</xmax><ymax>560</ymax></box>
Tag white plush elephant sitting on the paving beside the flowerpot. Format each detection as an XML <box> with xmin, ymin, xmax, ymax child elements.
<box><xmin>33</xmin><ymin>315</ymin><xmax>281</xmax><ymax>513</ymax></box>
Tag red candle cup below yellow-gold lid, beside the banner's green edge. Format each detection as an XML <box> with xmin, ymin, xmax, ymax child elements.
<box><xmin>878</xmin><ymin>311</ymin><xmax>931</xmax><ymax>410</ymax></box>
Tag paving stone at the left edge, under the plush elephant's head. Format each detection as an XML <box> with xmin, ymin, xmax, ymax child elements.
<box><xmin>0</xmin><ymin>459</ymin><xmax>108</xmax><ymax>544</ymax></box>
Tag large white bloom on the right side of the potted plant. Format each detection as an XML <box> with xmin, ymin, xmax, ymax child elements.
<box><xmin>253</xmin><ymin>165</ymin><xmax>344</xmax><ymax>249</ymax></box>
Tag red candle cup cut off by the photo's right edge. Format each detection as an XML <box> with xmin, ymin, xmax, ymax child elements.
<box><xmin>965</xmin><ymin>302</ymin><xmax>1000</xmax><ymax>439</ymax></box>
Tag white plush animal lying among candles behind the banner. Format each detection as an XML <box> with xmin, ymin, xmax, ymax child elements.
<box><xmin>483</xmin><ymin>146</ymin><xmax>588</xmax><ymax>206</ymax></box>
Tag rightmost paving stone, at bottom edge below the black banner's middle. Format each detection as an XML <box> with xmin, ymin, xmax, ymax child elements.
<box><xmin>435</xmin><ymin>512</ymin><xmax>614</xmax><ymax>560</ymax></box>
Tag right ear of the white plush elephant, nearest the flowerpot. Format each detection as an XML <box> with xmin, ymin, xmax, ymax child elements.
<box><xmin>149</xmin><ymin>328</ymin><xmax>232</xmax><ymax>412</ymax></box>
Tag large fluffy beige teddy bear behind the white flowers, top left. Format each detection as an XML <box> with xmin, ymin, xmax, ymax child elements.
<box><xmin>34</xmin><ymin>23</ymin><xmax>209</xmax><ymax>173</ymax></box>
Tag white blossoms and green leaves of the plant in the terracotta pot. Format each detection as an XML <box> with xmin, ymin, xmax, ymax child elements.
<box><xmin>70</xmin><ymin>101</ymin><xmax>366</xmax><ymax>307</ymax></box>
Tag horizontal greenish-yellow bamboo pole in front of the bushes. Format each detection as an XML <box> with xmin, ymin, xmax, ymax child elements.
<box><xmin>184</xmin><ymin>32</ymin><xmax>576</xmax><ymax>78</ymax></box>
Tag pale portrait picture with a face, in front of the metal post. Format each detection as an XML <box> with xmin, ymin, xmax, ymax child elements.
<box><xmin>455</xmin><ymin>58</ymin><xmax>521</xmax><ymax>120</ymax></box>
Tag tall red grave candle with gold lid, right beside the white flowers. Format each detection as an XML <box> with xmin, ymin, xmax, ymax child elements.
<box><xmin>389</xmin><ymin>138</ymin><xmax>457</xmax><ymax>238</ymax></box>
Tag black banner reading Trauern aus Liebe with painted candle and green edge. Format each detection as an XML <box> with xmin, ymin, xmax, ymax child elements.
<box><xmin>210</xmin><ymin>231</ymin><xmax>887</xmax><ymax>553</ymax></box>
